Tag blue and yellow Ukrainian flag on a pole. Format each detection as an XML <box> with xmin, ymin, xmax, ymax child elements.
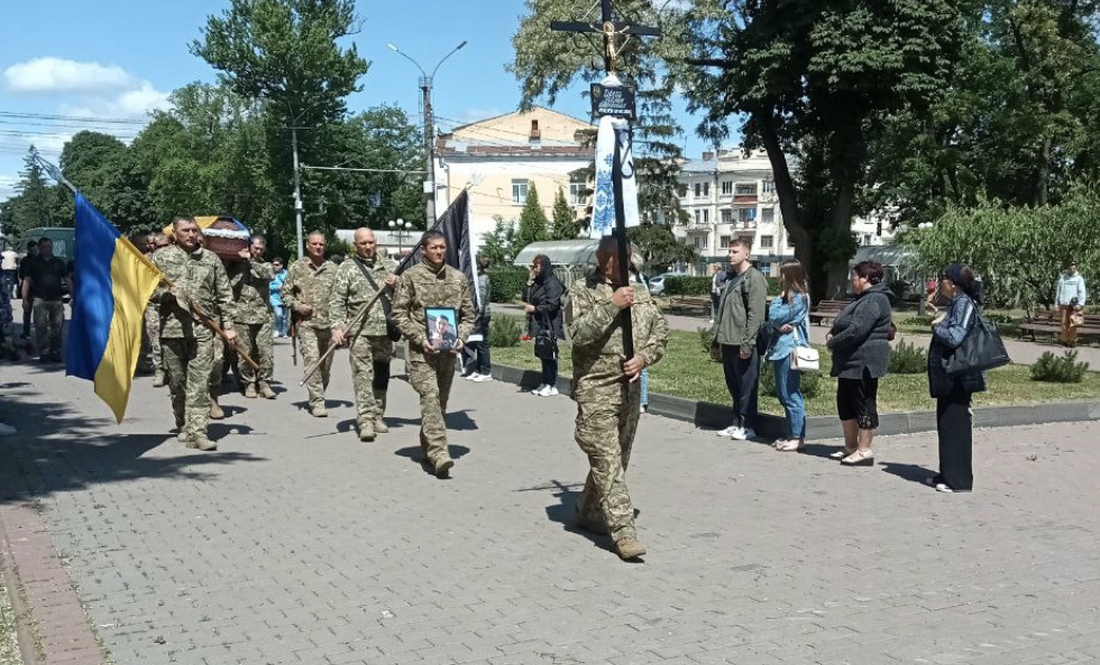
<box><xmin>65</xmin><ymin>192</ymin><xmax>164</xmax><ymax>422</ymax></box>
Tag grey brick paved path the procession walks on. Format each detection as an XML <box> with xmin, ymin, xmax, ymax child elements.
<box><xmin>0</xmin><ymin>345</ymin><xmax>1100</xmax><ymax>665</ymax></box>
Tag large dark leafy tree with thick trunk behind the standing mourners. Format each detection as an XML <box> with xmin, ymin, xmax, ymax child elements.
<box><xmin>679</xmin><ymin>0</ymin><xmax>965</xmax><ymax>298</ymax></box>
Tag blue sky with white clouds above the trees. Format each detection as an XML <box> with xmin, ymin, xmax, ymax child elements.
<box><xmin>0</xmin><ymin>0</ymin><xmax>704</xmax><ymax>200</ymax></box>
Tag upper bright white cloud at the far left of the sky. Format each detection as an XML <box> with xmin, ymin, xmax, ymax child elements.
<box><xmin>3</xmin><ymin>57</ymin><xmax>141</xmax><ymax>95</ymax></box>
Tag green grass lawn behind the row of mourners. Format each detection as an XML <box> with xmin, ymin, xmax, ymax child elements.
<box><xmin>493</xmin><ymin>331</ymin><xmax>1100</xmax><ymax>415</ymax></box>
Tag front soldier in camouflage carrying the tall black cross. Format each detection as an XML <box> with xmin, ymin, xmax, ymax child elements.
<box><xmin>565</xmin><ymin>236</ymin><xmax>669</xmax><ymax>561</ymax></box>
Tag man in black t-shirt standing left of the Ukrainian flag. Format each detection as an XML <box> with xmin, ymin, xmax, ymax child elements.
<box><xmin>23</xmin><ymin>237</ymin><xmax>76</xmax><ymax>363</ymax></box>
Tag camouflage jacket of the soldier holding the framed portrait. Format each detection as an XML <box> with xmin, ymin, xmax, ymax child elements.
<box><xmin>394</xmin><ymin>263</ymin><xmax>476</xmax><ymax>356</ymax></box>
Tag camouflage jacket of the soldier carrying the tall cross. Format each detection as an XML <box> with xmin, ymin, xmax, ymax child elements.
<box><xmin>564</xmin><ymin>274</ymin><xmax>669</xmax><ymax>399</ymax></box>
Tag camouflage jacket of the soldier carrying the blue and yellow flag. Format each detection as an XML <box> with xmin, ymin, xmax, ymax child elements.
<box><xmin>151</xmin><ymin>245</ymin><xmax>233</xmax><ymax>339</ymax></box>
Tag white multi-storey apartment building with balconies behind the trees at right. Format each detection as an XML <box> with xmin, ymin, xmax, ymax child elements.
<box><xmin>673</xmin><ymin>148</ymin><xmax>892</xmax><ymax>275</ymax></box>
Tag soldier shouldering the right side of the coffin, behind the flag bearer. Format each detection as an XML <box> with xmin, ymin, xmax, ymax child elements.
<box><xmin>229</xmin><ymin>235</ymin><xmax>275</xmax><ymax>399</ymax></box>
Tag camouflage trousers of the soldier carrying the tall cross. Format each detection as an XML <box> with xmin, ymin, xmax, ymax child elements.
<box><xmin>575</xmin><ymin>384</ymin><xmax>641</xmax><ymax>541</ymax></box>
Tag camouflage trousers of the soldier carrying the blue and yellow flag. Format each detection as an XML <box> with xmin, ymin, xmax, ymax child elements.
<box><xmin>161</xmin><ymin>331</ymin><xmax>215</xmax><ymax>436</ymax></box>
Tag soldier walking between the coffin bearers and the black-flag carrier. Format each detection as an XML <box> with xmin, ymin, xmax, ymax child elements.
<box><xmin>282</xmin><ymin>232</ymin><xmax>337</xmax><ymax>418</ymax></box>
